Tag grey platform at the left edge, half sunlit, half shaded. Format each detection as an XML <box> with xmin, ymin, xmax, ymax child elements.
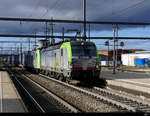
<box><xmin>0</xmin><ymin>71</ymin><xmax>28</xmax><ymax>113</ymax></box>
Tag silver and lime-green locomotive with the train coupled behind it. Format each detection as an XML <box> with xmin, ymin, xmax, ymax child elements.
<box><xmin>18</xmin><ymin>41</ymin><xmax>106</xmax><ymax>85</ymax></box>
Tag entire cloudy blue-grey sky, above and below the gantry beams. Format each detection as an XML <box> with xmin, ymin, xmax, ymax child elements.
<box><xmin>0</xmin><ymin>0</ymin><xmax>150</xmax><ymax>49</ymax></box>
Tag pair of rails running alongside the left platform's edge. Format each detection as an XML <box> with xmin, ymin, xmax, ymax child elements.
<box><xmin>9</xmin><ymin>70</ymin><xmax>80</xmax><ymax>113</ymax></box>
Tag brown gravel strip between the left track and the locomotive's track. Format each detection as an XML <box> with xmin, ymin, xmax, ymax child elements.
<box><xmin>25</xmin><ymin>72</ymin><xmax>122</xmax><ymax>112</ymax></box>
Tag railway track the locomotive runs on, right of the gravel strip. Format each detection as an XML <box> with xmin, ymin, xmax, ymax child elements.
<box><xmin>16</xmin><ymin>68</ymin><xmax>149</xmax><ymax>112</ymax></box>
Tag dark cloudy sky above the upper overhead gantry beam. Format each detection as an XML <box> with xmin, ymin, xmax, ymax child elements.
<box><xmin>0</xmin><ymin>0</ymin><xmax>150</xmax><ymax>22</ymax></box>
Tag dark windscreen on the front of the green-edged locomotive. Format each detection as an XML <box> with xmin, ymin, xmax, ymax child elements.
<box><xmin>72</xmin><ymin>45</ymin><xmax>96</xmax><ymax>56</ymax></box>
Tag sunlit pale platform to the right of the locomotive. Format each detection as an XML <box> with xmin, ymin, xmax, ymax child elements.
<box><xmin>101</xmin><ymin>70</ymin><xmax>150</xmax><ymax>95</ymax></box>
